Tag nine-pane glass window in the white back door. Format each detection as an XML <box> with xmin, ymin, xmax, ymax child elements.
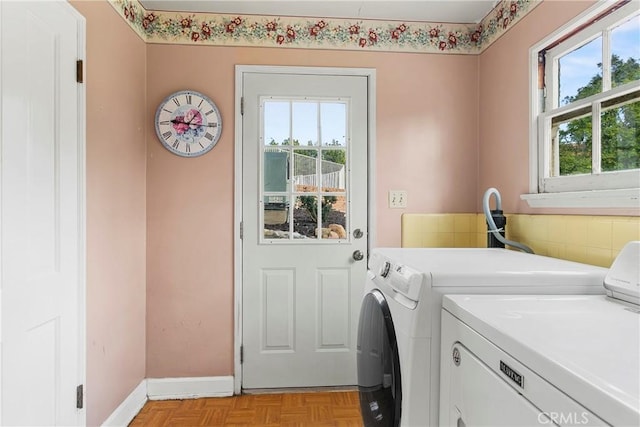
<box><xmin>260</xmin><ymin>97</ymin><xmax>349</xmax><ymax>243</ymax></box>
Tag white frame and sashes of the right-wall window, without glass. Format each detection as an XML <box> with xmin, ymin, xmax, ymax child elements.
<box><xmin>521</xmin><ymin>1</ymin><xmax>640</xmax><ymax>208</ymax></box>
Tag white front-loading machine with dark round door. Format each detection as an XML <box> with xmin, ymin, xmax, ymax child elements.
<box><xmin>357</xmin><ymin>248</ymin><xmax>607</xmax><ymax>427</ymax></box>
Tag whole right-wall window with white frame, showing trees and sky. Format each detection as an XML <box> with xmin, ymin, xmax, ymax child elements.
<box><xmin>524</xmin><ymin>1</ymin><xmax>640</xmax><ymax>207</ymax></box>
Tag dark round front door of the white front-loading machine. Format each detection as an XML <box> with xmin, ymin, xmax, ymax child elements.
<box><xmin>358</xmin><ymin>290</ymin><xmax>402</xmax><ymax>427</ymax></box>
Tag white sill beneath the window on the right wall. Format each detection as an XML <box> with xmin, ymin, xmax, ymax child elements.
<box><xmin>520</xmin><ymin>188</ymin><xmax>640</xmax><ymax>208</ymax></box>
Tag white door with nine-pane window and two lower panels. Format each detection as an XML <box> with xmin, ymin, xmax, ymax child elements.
<box><xmin>242</xmin><ymin>73</ymin><xmax>368</xmax><ymax>389</ymax></box>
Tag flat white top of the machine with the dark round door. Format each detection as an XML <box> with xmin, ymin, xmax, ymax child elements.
<box><xmin>370</xmin><ymin>248</ymin><xmax>608</xmax><ymax>293</ymax></box>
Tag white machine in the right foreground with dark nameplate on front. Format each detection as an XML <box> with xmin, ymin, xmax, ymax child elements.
<box><xmin>440</xmin><ymin>242</ymin><xmax>640</xmax><ymax>427</ymax></box>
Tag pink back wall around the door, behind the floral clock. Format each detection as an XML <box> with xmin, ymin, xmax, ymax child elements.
<box><xmin>145</xmin><ymin>45</ymin><xmax>478</xmax><ymax>377</ymax></box>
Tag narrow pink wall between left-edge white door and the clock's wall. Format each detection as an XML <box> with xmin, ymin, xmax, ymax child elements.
<box><xmin>72</xmin><ymin>1</ymin><xmax>148</xmax><ymax>425</ymax></box>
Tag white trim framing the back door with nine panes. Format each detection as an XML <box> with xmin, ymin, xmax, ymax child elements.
<box><xmin>233</xmin><ymin>65</ymin><xmax>376</xmax><ymax>394</ymax></box>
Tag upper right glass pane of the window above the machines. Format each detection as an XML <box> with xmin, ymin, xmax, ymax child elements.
<box><xmin>611</xmin><ymin>15</ymin><xmax>640</xmax><ymax>87</ymax></box>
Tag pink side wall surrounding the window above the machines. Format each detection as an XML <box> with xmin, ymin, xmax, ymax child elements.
<box><xmin>476</xmin><ymin>0</ymin><xmax>638</xmax><ymax>215</ymax></box>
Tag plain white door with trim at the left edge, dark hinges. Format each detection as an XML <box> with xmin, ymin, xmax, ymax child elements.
<box><xmin>0</xmin><ymin>1</ymin><xmax>85</xmax><ymax>426</ymax></box>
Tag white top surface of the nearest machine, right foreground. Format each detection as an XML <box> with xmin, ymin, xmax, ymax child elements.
<box><xmin>443</xmin><ymin>295</ymin><xmax>640</xmax><ymax>425</ymax></box>
